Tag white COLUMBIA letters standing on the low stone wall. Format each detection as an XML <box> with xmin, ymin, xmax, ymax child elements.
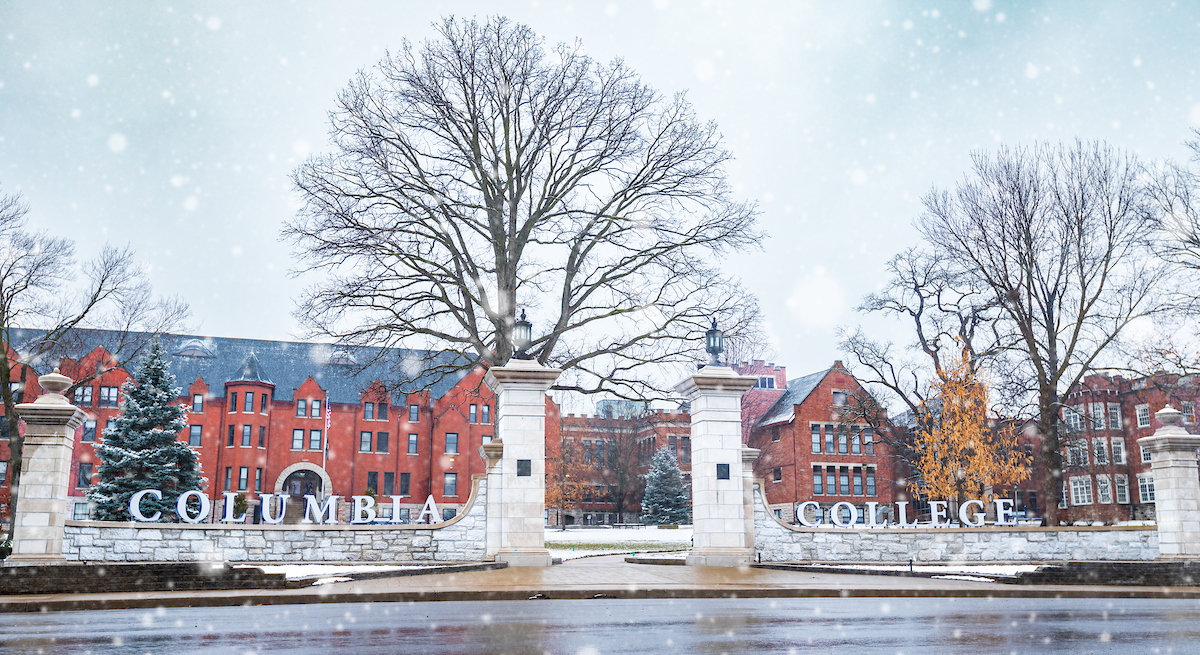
<box><xmin>130</xmin><ymin>489</ymin><xmax>451</xmax><ymax>525</ymax></box>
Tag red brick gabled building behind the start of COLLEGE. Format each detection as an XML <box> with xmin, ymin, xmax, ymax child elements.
<box><xmin>736</xmin><ymin>361</ymin><xmax>898</xmax><ymax>521</ymax></box>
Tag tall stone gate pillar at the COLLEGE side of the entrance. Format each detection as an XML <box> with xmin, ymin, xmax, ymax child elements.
<box><xmin>676</xmin><ymin>366</ymin><xmax>758</xmax><ymax>566</ymax></box>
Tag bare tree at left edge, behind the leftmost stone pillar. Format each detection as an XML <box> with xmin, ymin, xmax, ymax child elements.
<box><xmin>0</xmin><ymin>185</ymin><xmax>188</xmax><ymax>537</ymax></box>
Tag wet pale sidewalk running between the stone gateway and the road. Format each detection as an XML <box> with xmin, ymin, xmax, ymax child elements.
<box><xmin>0</xmin><ymin>555</ymin><xmax>1200</xmax><ymax>612</ymax></box>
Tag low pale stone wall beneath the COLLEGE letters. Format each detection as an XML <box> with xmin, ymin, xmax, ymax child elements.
<box><xmin>754</xmin><ymin>485</ymin><xmax>1158</xmax><ymax>564</ymax></box>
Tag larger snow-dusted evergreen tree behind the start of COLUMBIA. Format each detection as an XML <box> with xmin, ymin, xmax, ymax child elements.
<box><xmin>88</xmin><ymin>341</ymin><xmax>206</xmax><ymax>522</ymax></box>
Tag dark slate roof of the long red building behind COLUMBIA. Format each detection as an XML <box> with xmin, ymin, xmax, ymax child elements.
<box><xmin>13</xmin><ymin>329</ymin><xmax>466</xmax><ymax>403</ymax></box>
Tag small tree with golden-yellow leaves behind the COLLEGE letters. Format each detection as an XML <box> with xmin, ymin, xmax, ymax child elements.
<box><xmin>914</xmin><ymin>349</ymin><xmax>1030</xmax><ymax>504</ymax></box>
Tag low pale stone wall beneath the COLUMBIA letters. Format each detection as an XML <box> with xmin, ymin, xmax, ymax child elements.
<box><xmin>62</xmin><ymin>475</ymin><xmax>487</xmax><ymax>563</ymax></box>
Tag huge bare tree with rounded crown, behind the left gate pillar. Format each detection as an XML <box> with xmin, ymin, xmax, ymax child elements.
<box><xmin>283</xmin><ymin>18</ymin><xmax>761</xmax><ymax>398</ymax></box>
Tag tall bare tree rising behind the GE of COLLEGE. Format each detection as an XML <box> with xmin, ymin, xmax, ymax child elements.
<box><xmin>917</xmin><ymin>142</ymin><xmax>1165</xmax><ymax>524</ymax></box>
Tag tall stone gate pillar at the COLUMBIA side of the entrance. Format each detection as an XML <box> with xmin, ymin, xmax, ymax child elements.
<box><xmin>485</xmin><ymin>359</ymin><xmax>562</xmax><ymax>566</ymax></box>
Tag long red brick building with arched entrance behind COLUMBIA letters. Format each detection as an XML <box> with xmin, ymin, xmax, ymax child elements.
<box><xmin>0</xmin><ymin>332</ymin><xmax>496</xmax><ymax>519</ymax></box>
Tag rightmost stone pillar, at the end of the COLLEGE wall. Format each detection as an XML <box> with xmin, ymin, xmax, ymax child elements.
<box><xmin>1138</xmin><ymin>405</ymin><xmax>1200</xmax><ymax>559</ymax></box>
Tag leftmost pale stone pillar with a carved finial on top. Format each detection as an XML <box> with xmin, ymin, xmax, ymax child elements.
<box><xmin>7</xmin><ymin>368</ymin><xmax>88</xmax><ymax>564</ymax></box>
